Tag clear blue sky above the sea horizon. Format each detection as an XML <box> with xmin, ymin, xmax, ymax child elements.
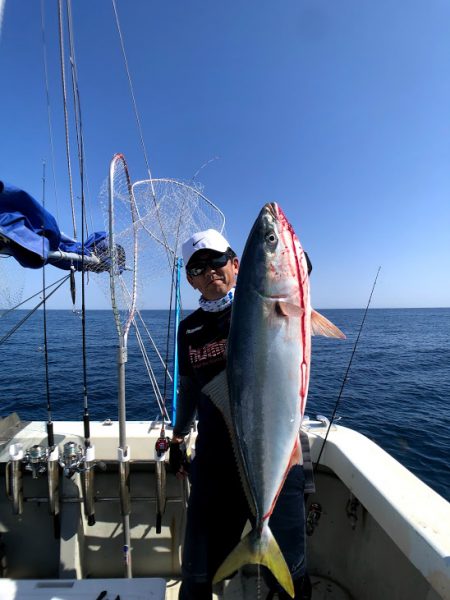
<box><xmin>0</xmin><ymin>0</ymin><xmax>450</xmax><ymax>308</ymax></box>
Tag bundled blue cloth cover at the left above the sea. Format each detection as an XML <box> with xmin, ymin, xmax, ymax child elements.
<box><xmin>0</xmin><ymin>182</ymin><xmax>108</xmax><ymax>270</ymax></box>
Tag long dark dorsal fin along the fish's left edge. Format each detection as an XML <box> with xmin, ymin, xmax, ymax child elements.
<box><xmin>202</xmin><ymin>370</ymin><xmax>256</xmax><ymax>516</ymax></box>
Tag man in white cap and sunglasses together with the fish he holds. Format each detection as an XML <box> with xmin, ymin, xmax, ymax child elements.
<box><xmin>171</xmin><ymin>203</ymin><xmax>343</xmax><ymax>600</ymax></box>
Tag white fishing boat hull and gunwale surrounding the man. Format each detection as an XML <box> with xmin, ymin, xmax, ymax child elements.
<box><xmin>0</xmin><ymin>421</ymin><xmax>450</xmax><ymax>600</ymax></box>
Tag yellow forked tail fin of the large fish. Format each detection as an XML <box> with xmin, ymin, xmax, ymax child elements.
<box><xmin>213</xmin><ymin>525</ymin><xmax>295</xmax><ymax>598</ymax></box>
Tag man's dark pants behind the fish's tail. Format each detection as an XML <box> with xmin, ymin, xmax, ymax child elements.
<box><xmin>179</xmin><ymin>457</ymin><xmax>306</xmax><ymax>600</ymax></box>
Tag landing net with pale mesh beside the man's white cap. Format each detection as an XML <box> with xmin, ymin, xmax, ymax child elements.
<box><xmin>97</xmin><ymin>155</ymin><xmax>225</xmax><ymax>421</ymax></box>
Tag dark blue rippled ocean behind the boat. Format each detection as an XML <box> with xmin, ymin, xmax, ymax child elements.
<box><xmin>0</xmin><ymin>308</ymin><xmax>450</xmax><ymax>500</ymax></box>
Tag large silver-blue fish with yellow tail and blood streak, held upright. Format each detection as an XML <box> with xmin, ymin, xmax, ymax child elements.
<box><xmin>203</xmin><ymin>203</ymin><xmax>345</xmax><ymax>597</ymax></box>
